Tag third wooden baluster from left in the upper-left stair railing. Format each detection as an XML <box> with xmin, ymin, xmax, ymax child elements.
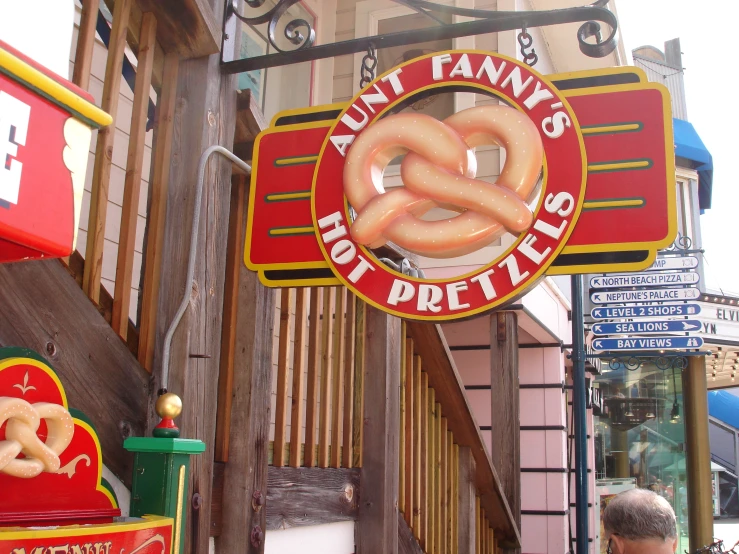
<box><xmin>111</xmin><ymin>13</ymin><xmax>157</xmax><ymax>340</ymax></box>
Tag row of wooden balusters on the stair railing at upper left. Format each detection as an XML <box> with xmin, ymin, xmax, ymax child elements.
<box><xmin>65</xmin><ymin>0</ymin><xmax>179</xmax><ymax>370</ymax></box>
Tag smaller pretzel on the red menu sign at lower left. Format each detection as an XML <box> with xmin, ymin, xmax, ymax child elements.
<box><xmin>0</xmin><ymin>397</ymin><xmax>74</xmax><ymax>479</ymax></box>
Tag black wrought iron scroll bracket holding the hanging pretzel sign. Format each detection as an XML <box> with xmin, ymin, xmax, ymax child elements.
<box><xmin>221</xmin><ymin>0</ymin><xmax>618</xmax><ymax>73</ymax></box>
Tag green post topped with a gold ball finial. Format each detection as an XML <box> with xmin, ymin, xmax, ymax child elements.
<box><xmin>123</xmin><ymin>393</ymin><xmax>205</xmax><ymax>554</ymax></box>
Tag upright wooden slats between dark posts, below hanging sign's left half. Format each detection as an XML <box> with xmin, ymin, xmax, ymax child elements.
<box><xmin>270</xmin><ymin>287</ymin><xmax>364</xmax><ymax>468</ymax></box>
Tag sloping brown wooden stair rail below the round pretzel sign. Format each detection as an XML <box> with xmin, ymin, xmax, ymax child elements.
<box><xmin>408</xmin><ymin>322</ymin><xmax>520</xmax><ymax>544</ymax></box>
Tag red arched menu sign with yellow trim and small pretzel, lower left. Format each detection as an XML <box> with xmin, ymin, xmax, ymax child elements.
<box><xmin>0</xmin><ymin>348</ymin><xmax>174</xmax><ymax>554</ymax></box>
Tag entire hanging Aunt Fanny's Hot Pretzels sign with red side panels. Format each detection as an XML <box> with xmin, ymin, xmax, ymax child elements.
<box><xmin>245</xmin><ymin>51</ymin><xmax>676</xmax><ymax>321</ymax></box>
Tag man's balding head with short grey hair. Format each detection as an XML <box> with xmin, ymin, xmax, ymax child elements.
<box><xmin>603</xmin><ymin>489</ymin><xmax>677</xmax><ymax>554</ymax></box>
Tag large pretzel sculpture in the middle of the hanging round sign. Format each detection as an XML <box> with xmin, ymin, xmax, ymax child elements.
<box><xmin>344</xmin><ymin>106</ymin><xmax>544</xmax><ymax>258</ymax></box>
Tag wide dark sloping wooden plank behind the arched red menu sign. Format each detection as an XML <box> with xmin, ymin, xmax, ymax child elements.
<box><xmin>0</xmin><ymin>260</ymin><xmax>149</xmax><ymax>480</ymax></box>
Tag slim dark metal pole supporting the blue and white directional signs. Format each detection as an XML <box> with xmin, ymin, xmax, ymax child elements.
<box><xmin>570</xmin><ymin>275</ymin><xmax>588</xmax><ymax>554</ymax></box>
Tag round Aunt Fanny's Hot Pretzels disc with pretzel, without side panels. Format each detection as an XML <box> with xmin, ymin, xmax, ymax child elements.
<box><xmin>312</xmin><ymin>51</ymin><xmax>586</xmax><ymax>321</ymax></box>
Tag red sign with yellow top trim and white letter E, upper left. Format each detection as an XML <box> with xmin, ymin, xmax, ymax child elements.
<box><xmin>0</xmin><ymin>41</ymin><xmax>112</xmax><ymax>263</ymax></box>
